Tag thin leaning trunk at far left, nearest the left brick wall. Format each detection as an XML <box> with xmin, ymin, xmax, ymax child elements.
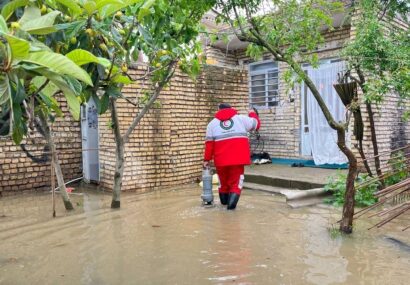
<box><xmin>39</xmin><ymin>115</ymin><xmax>74</xmax><ymax>211</ymax></box>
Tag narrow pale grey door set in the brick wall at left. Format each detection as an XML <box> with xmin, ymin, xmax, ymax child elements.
<box><xmin>81</xmin><ymin>98</ymin><xmax>100</xmax><ymax>183</ymax></box>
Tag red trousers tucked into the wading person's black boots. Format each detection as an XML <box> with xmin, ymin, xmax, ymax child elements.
<box><xmin>216</xmin><ymin>165</ymin><xmax>244</xmax><ymax>195</ymax></box>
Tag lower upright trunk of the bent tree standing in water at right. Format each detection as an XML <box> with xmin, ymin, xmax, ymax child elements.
<box><xmin>337</xmin><ymin>130</ymin><xmax>357</xmax><ymax>234</ymax></box>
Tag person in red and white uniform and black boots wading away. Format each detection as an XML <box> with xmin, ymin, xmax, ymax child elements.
<box><xmin>204</xmin><ymin>103</ymin><xmax>260</xmax><ymax>210</ymax></box>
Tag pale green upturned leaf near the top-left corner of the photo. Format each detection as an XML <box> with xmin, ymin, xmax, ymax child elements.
<box><xmin>20</xmin><ymin>7</ymin><xmax>60</xmax><ymax>35</ymax></box>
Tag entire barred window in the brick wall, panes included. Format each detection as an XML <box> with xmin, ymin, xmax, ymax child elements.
<box><xmin>249</xmin><ymin>60</ymin><xmax>279</xmax><ymax>108</ymax></box>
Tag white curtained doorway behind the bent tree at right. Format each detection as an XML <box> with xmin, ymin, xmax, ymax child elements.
<box><xmin>300</xmin><ymin>60</ymin><xmax>347</xmax><ymax>165</ymax></box>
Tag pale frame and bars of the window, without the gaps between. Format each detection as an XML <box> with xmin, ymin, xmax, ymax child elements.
<box><xmin>248</xmin><ymin>59</ymin><xmax>280</xmax><ymax>109</ymax></box>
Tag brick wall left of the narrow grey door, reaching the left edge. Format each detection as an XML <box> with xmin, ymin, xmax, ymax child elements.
<box><xmin>0</xmin><ymin>96</ymin><xmax>82</xmax><ymax>194</ymax></box>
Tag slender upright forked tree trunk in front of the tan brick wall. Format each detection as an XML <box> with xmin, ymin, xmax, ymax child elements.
<box><xmin>110</xmin><ymin>98</ymin><xmax>124</xmax><ymax>209</ymax></box>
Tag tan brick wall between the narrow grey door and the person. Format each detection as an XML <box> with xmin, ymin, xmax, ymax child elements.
<box><xmin>99</xmin><ymin>66</ymin><xmax>247</xmax><ymax>192</ymax></box>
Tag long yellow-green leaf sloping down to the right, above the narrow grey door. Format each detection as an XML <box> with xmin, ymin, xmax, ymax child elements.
<box><xmin>23</xmin><ymin>51</ymin><xmax>93</xmax><ymax>86</ymax></box>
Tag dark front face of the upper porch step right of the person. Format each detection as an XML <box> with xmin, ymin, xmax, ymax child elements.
<box><xmin>245</xmin><ymin>173</ymin><xmax>324</xmax><ymax>190</ymax></box>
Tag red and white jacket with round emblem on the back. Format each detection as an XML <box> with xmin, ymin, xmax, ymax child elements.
<box><xmin>204</xmin><ymin>108</ymin><xmax>260</xmax><ymax>167</ymax></box>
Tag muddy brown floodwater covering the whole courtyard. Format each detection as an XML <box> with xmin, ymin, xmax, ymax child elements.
<box><xmin>0</xmin><ymin>187</ymin><xmax>410</xmax><ymax>285</ymax></box>
